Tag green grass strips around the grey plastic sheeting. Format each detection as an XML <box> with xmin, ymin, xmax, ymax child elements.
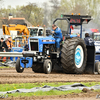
<box><xmin>0</xmin><ymin>82</ymin><xmax>100</xmax><ymax>97</ymax></box>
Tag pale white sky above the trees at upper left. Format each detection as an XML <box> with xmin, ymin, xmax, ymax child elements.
<box><xmin>2</xmin><ymin>0</ymin><xmax>49</xmax><ymax>8</ymax></box>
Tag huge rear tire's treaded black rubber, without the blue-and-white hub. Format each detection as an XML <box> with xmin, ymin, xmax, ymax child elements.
<box><xmin>61</xmin><ymin>38</ymin><xmax>87</xmax><ymax>74</ymax></box>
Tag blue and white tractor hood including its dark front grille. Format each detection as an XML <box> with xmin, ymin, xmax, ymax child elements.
<box><xmin>29</xmin><ymin>36</ymin><xmax>55</xmax><ymax>52</ymax></box>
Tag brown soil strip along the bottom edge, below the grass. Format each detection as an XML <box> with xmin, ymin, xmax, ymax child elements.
<box><xmin>3</xmin><ymin>91</ymin><xmax>100</xmax><ymax>100</ymax></box>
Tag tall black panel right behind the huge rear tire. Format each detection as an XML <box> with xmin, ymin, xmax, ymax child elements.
<box><xmin>85</xmin><ymin>46</ymin><xmax>95</xmax><ymax>74</ymax></box>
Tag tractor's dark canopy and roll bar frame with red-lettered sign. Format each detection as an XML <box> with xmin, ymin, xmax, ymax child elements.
<box><xmin>53</xmin><ymin>14</ymin><xmax>91</xmax><ymax>38</ymax></box>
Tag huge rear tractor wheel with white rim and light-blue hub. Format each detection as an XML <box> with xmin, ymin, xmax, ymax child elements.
<box><xmin>61</xmin><ymin>38</ymin><xmax>87</xmax><ymax>74</ymax></box>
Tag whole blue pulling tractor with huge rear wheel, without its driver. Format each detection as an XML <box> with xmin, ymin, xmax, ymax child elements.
<box><xmin>16</xmin><ymin>15</ymin><xmax>100</xmax><ymax>74</ymax></box>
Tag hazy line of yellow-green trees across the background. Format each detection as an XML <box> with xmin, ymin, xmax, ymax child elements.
<box><xmin>0</xmin><ymin>0</ymin><xmax>100</xmax><ymax>27</ymax></box>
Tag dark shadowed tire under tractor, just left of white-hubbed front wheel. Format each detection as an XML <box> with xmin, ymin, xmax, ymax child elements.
<box><xmin>32</xmin><ymin>63</ymin><xmax>43</xmax><ymax>73</ymax></box>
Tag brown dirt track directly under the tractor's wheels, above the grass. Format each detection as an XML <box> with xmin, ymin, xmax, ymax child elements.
<box><xmin>0</xmin><ymin>68</ymin><xmax>100</xmax><ymax>84</ymax></box>
